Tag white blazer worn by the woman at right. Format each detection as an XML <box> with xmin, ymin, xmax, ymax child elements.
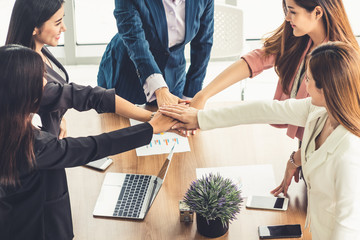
<box><xmin>198</xmin><ymin>98</ymin><xmax>360</xmax><ymax>240</ymax></box>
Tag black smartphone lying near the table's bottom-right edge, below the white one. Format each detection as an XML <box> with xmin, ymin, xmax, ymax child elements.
<box><xmin>259</xmin><ymin>224</ymin><xmax>302</xmax><ymax>239</ymax></box>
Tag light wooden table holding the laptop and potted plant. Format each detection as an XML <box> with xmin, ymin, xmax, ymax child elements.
<box><xmin>66</xmin><ymin>102</ymin><xmax>311</xmax><ymax>240</ymax></box>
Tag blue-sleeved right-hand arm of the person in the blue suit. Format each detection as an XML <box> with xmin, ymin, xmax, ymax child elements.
<box><xmin>183</xmin><ymin>0</ymin><xmax>214</xmax><ymax>97</ymax></box>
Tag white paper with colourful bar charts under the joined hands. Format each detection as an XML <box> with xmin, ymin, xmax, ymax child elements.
<box><xmin>130</xmin><ymin>119</ymin><xmax>190</xmax><ymax>156</ymax></box>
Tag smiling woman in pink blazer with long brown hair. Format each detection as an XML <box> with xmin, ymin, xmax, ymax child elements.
<box><xmin>190</xmin><ymin>0</ymin><xmax>359</xmax><ymax>195</ymax></box>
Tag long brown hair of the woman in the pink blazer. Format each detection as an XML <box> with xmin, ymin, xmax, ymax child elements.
<box><xmin>264</xmin><ymin>0</ymin><xmax>359</xmax><ymax>94</ymax></box>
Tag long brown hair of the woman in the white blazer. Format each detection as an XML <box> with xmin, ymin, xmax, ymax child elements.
<box><xmin>308</xmin><ymin>42</ymin><xmax>360</xmax><ymax>137</ymax></box>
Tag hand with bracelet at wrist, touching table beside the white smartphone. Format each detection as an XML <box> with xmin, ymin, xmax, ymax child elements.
<box><xmin>271</xmin><ymin>149</ymin><xmax>301</xmax><ymax>197</ymax></box>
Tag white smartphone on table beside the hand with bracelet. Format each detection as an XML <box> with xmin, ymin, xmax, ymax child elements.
<box><xmin>246</xmin><ymin>196</ymin><xmax>289</xmax><ymax>211</ymax></box>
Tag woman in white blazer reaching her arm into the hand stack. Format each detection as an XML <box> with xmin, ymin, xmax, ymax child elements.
<box><xmin>160</xmin><ymin>42</ymin><xmax>360</xmax><ymax>240</ymax></box>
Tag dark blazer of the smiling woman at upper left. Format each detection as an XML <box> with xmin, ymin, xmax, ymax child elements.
<box><xmin>39</xmin><ymin>47</ymin><xmax>115</xmax><ymax>136</ymax></box>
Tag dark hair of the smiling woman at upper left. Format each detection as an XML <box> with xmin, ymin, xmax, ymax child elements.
<box><xmin>5</xmin><ymin>0</ymin><xmax>64</xmax><ymax>50</ymax></box>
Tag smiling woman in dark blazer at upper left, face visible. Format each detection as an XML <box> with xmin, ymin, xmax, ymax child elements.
<box><xmin>0</xmin><ymin>0</ymin><xmax>169</xmax><ymax>239</ymax></box>
